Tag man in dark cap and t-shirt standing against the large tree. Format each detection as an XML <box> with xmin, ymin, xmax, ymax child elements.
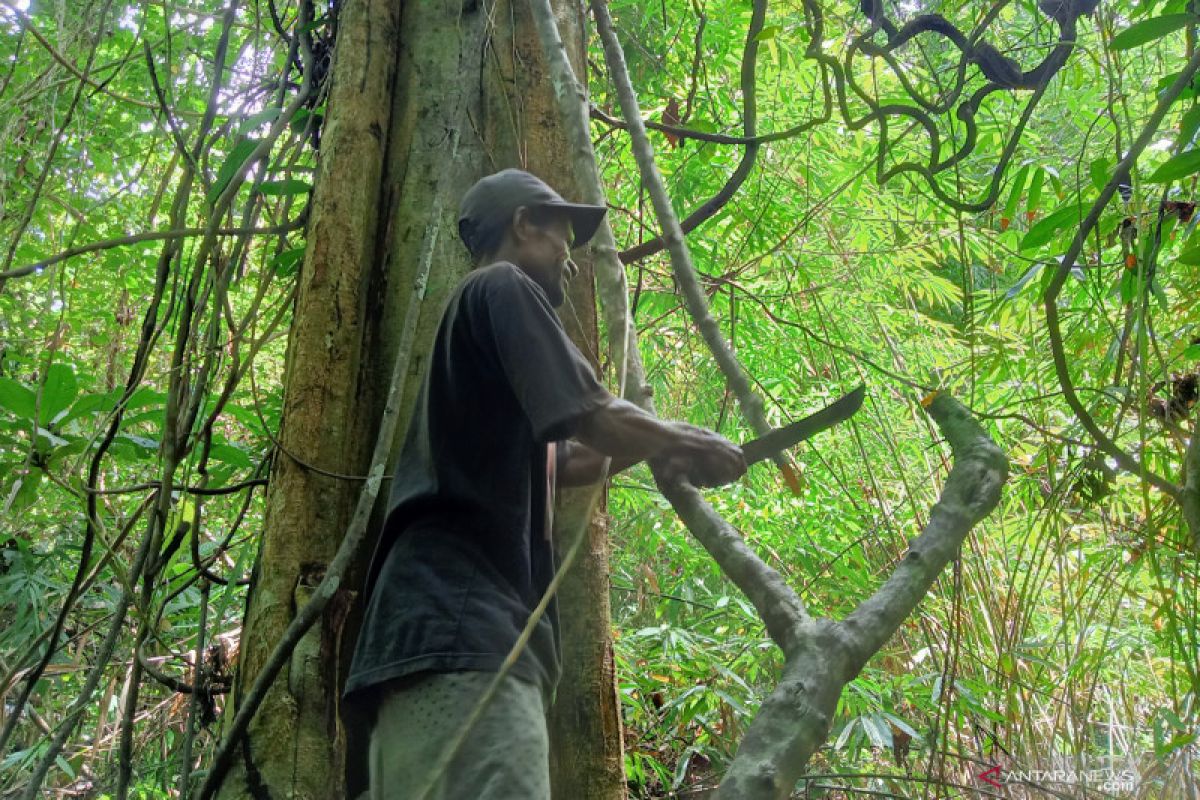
<box><xmin>346</xmin><ymin>169</ymin><xmax>745</xmax><ymax>800</ymax></box>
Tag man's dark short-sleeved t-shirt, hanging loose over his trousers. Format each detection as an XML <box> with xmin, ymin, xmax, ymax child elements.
<box><xmin>346</xmin><ymin>261</ymin><xmax>608</xmax><ymax>696</ymax></box>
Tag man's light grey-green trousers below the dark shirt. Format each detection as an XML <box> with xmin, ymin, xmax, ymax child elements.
<box><xmin>370</xmin><ymin>672</ymin><xmax>550</xmax><ymax>800</ymax></box>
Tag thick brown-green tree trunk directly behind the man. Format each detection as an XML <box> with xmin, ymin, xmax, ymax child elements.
<box><xmin>221</xmin><ymin>0</ymin><xmax>624</xmax><ymax>800</ymax></box>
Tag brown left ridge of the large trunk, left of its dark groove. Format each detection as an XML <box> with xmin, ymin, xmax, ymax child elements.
<box><xmin>213</xmin><ymin>0</ymin><xmax>398</xmax><ymax>800</ymax></box>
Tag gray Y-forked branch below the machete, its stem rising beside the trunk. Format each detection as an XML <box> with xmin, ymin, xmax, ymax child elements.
<box><xmin>530</xmin><ymin>6</ymin><xmax>1008</xmax><ymax>800</ymax></box>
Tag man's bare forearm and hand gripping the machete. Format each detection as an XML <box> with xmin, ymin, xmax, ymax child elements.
<box><xmin>559</xmin><ymin>397</ymin><xmax>746</xmax><ymax>486</ymax></box>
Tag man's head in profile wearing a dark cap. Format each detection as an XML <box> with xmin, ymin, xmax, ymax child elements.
<box><xmin>458</xmin><ymin>169</ymin><xmax>607</xmax><ymax>306</ymax></box>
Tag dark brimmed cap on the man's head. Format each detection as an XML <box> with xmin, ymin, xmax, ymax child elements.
<box><xmin>458</xmin><ymin>169</ymin><xmax>608</xmax><ymax>254</ymax></box>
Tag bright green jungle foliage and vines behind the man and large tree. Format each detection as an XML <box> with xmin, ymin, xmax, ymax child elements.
<box><xmin>0</xmin><ymin>0</ymin><xmax>1200</xmax><ymax>798</ymax></box>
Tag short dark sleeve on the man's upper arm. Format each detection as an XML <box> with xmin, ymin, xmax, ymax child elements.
<box><xmin>475</xmin><ymin>264</ymin><xmax>611</xmax><ymax>441</ymax></box>
